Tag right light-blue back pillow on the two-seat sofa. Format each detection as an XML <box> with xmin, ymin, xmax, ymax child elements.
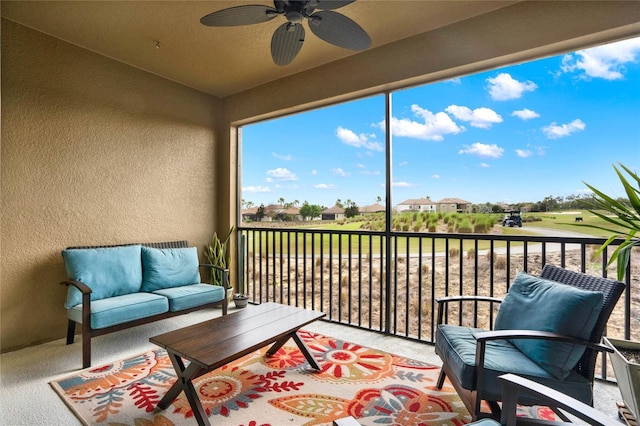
<box><xmin>142</xmin><ymin>247</ymin><xmax>200</xmax><ymax>291</ymax></box>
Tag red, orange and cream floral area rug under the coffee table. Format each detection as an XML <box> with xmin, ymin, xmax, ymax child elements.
<box><xmin>51</xmin><ymin>330</ymin><xmax>552</xmax><ymax>426</ymax></box>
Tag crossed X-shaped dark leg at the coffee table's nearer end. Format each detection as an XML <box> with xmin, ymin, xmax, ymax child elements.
<box><xmin>158</xmin><ymin>352</ymin><xmax>211</xmax><ymax>426</ymax></box>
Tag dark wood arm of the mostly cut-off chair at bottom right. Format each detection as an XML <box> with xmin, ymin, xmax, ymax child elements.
<box><xmin>498</xmin><ymin>374</ymin><xmax>620</xmax><ymax>426</ymax></box>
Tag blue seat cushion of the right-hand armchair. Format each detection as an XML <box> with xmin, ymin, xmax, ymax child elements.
<box><xmin>435</xmin><ymin>324</ymin><xmax>593</xmax><ymax>405</ymax></box>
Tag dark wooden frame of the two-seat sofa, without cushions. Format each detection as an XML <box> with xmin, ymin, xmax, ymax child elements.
<box><xmin>60</xmin><ymin>240</ymin><xmax>229</xmax><ymax>368</ymax></box>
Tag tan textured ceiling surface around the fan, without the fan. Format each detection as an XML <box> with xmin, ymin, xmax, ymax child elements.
<box><xmin>1</xmin><ymin>0</ymin><xmax>517</xmax><ymax>98</ymax></box>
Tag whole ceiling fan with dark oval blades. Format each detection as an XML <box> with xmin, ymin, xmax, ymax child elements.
<box><xmin>200</xmin><ymin>0</ymin><xmax>371</xmax><ymax>66</ymax></box>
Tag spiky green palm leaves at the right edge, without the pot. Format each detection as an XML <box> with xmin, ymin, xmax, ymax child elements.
<box><xmin>584</xmin><ymin>163</ymin><xmax>640</xmax><ymax>281</ymax></box>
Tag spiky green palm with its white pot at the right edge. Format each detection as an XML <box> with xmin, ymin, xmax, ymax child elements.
<box><xmin>583</xmin><ymin>163</ymin><xmax>640</xmax><ymax>419</ymax></box>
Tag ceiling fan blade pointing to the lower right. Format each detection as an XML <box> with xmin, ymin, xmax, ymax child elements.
<box><xmin>309</xmin><ymin>10</ymin><xmax>371</xmax><ymax>50</ymax></box>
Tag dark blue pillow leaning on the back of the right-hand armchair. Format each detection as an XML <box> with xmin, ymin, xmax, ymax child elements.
<box><xmin>494</xmin><ymin>272</ymin><xmax>604</xmax><ymax>380</ymax></box>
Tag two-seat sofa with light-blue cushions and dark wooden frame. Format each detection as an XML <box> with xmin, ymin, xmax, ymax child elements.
<box><xmin>61</xmin><ymin>241</ymin><xmax>229</xmax><ymax>368</ymax></box>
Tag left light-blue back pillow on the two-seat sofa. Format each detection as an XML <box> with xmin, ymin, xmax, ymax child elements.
<box><xmin>62</xmin><ymin>245</ymin><xmax>142</xmax><ymax>309</ymax></box>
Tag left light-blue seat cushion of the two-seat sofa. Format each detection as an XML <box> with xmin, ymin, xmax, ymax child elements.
<box><xmin>67</xmin><ymin>293</ymin><xmax>169</xmax><ymax>329</ymax></box>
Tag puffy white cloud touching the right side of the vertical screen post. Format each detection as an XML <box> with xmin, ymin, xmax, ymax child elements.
<box><xmin>379</xmin><ymin>105</ymin><xmax>464</xmax><ymax>141</ymax></box>
